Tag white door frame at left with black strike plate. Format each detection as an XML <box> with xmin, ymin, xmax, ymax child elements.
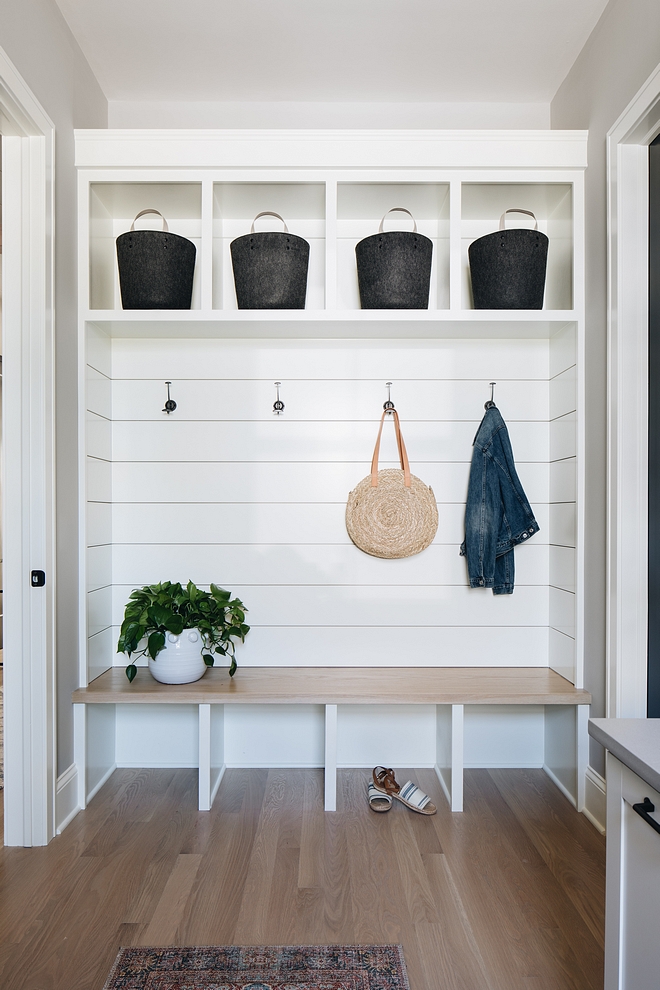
<box><xmin>0</xmin><ymin>49</ymin><xmax>56</xmax><ymax>846</ymax></box>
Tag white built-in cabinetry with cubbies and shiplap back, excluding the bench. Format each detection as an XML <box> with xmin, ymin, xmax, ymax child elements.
<box><xmin>76</xmin><ymin>131</ymin><xmax>586</xmax><ymax>798</ymax></box>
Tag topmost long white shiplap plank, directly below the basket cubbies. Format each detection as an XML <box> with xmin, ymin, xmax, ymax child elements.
<box><xmin>111</xmin><ymin>338</ymin><xmax>548</xmax><ymax>382</ymax></box>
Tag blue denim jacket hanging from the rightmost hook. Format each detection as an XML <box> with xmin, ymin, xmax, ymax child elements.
<box><xmin>461</xmin><ymin>406</ymin><xmax>539</xmax><ymax>595</ymax></box>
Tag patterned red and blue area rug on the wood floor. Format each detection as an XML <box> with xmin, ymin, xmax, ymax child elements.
<box><xmin>104</xmin><ymin>945</ymin><xmax>410</xmax><ymax>990</ymax></box>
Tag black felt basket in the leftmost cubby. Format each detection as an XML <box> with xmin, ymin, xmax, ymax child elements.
<box><xmin>117</xmin><ymin>210</ymin><xmax>197</xmax><ymax>309</ymax></box>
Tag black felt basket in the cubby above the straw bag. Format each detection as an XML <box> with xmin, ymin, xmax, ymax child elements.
<box><xmin>355</xmin><ymin>206</ymin><xmax>433</xmax><ymax>309</ymax></box>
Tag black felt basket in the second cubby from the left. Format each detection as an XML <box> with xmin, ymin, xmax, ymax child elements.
<box><xmin>230</xmin><ymin>210</ymin><xmax>309</xmax><ymax>309</ymax></box>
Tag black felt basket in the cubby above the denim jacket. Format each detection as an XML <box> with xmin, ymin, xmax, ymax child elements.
<box><xmin>468</xmin><ymin>209</ymin><xmax>549</xmax><ymax>309</ymax></box>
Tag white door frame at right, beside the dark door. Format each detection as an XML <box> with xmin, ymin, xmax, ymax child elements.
<box><xmin>607</xmin><ymin>66</ymin><xmax>660</xmax><ymax>718</ymax></box>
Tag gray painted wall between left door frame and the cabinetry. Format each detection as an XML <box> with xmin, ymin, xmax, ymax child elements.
<box><xmin>0</xmin><ymin>0</ymin><xmax>108</xmax><ymax>774</ymax></box>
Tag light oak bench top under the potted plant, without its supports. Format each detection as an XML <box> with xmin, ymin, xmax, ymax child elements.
<box><xmin>73</xmin><ymin>667</ymin><xmax>591</xmax><ymax>705</ymax></box>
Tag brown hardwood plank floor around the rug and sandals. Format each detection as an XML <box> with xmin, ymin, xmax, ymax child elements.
<box><xmin>0</xmin><ymin>770</ymin><xmax>605</xmax><ymax>990</ymax></box>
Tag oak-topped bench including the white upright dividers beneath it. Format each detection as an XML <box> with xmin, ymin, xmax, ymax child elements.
<box><xmin>73</xmin><ymin>667</ymin><xmax>591</xmax><ymax>811</ymax></box>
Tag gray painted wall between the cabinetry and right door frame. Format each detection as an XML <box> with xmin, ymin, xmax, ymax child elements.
<box><xmin>551</xmin><ymin>0</ymin><xmax>660</xmax><ymax>774</ymax></box>
